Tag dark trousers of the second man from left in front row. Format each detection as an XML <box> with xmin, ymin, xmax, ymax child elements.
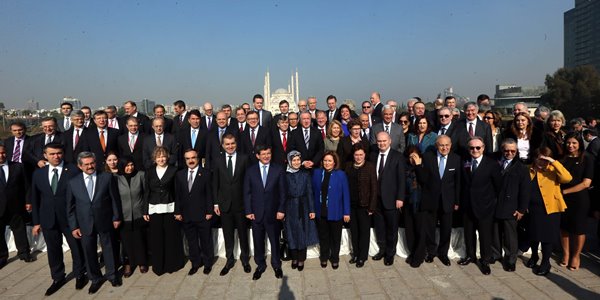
<box><xmin>42</xmin><ymin>220</ymin><xmax>85</xmax><ymax>281</ymax></box>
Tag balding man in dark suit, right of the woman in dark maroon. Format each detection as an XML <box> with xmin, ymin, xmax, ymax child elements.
<box><xmin>371</xmin><ymin>131</ymin><xmax>406</xmax><ymax>266</ymax></box>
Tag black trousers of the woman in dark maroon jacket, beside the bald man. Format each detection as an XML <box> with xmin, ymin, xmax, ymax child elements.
<box><xmin>350</xmin><ymin>207</ymin><xmax>371</xmax><ymax>261</ymax></box>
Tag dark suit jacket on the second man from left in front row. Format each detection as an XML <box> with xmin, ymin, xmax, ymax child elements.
<box><xmin>30</xmin><ymin>164</ymin><xmax>81</xmax><ymax>228</ymax></box>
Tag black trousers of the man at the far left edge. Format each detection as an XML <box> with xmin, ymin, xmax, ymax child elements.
<box><xmin>0</xmin><ymin>211</ymin><xmax>31</xmax><ymax>259</ymax></box>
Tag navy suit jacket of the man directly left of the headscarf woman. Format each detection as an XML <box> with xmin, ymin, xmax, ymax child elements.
<box><xmin>244</xmin><ymin>163</ymin><xmax>286</xmax><ymax>224</ymax></box>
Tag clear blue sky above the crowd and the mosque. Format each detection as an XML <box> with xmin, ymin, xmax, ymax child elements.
<box><xmin>0</xmin><ymin>0</ymin><xmax>574</xmax><ymax>108</ymax></box>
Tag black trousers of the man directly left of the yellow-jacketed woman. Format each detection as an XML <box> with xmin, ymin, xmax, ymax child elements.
<box><xmin>492</xmin><ymin>219</ymin><xmax>519</xmax><ymax>264</ymax></box>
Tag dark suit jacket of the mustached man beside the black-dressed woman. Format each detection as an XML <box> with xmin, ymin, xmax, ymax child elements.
<box><xmin>174</xmin><ymin>167</ymin><xmax>213</xmax><ymax>222</ymax></box>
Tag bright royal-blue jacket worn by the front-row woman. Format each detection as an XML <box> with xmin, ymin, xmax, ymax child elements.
<box><xmin>312</xmin><ymin>168</ymin><xmax>350</xmax><ymax>221</ymax></box>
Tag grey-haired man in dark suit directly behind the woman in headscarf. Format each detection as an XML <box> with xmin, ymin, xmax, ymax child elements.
<box><xmin>287</xmin><ymin>112</ymin><xmax>325</xmax><ymax>170</ymax></box>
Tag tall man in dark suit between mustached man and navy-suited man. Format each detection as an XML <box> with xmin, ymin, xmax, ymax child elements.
<box><xmin>212</xmin><ymin>133</ymin><xmax>252</xmax><ymax>276</ymax></box>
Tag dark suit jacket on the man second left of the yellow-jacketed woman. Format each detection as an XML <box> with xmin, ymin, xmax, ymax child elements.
<box><xmin>461</xmin><ymin>156</ymin><xmax>502</xmax><ymax>219</ymax></box>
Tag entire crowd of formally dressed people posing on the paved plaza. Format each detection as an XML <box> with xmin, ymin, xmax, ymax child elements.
<box><xmin>0</xmin><ymin>92</ymin><xmax>600</xmax><ymax>295</ymax></box>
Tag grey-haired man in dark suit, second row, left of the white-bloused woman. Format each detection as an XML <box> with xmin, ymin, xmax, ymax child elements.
<box><xmin>452</xmin><ymin>102</ymin><xmax>493</xmax><ymax>160</ymax></box>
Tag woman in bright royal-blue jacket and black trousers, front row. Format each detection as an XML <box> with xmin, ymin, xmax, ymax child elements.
<box><xmin>312</xmin><ymin>151</ymin><xmax>350</xmax><ymax>269</ymax></box>
